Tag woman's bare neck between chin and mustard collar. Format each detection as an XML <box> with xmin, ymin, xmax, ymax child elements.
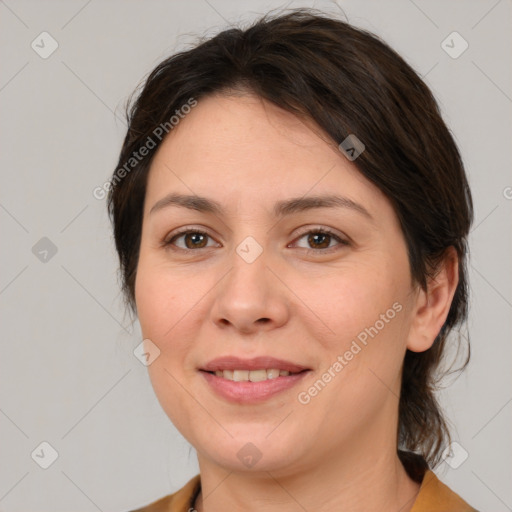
<box><xmin>195</xmin><ymin>444</ymin><xmax>420</xmax><ymax>512</ymax></box>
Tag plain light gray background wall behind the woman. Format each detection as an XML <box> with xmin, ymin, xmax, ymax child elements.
<box><xmin>0</xmin><ymin>0</ymin><xmax>512</xmax><ymax>512</ymax></box>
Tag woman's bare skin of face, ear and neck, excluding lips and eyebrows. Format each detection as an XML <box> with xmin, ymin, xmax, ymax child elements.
<box><xmin>135</xmin><ymin>94</ymin><xmax>458</xmax><ymax>512</ymax></box>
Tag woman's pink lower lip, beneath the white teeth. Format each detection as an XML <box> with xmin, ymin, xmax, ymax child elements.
<box><xmin>201</xmin><ymin>370</ymin><xmax>309</xmax><ymax>404</ymax></box>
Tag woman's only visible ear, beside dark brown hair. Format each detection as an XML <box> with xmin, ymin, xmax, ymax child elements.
<box><xmin>407</xmin><ymin>247</ymin><xmax>459</xmax><ymax>352</ymax></box>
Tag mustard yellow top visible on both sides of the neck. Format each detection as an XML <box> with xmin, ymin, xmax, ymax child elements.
<box><xmin>127</xmin><ymin>469</ymin><xmax>478</xmax><ymax>512</ymax></box>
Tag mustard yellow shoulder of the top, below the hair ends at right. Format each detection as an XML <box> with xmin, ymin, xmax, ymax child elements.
<box><xmin>411</xmin><ymin>469</ymin><xmax>478</xmax><ymax>512</ymax></box>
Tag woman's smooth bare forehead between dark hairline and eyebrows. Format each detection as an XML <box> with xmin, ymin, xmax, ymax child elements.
<box><xmin>147</xmin><ymin>95</ymin><xmax>387</xmax><ymax>222</ymax></box>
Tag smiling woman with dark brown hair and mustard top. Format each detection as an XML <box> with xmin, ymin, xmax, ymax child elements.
<box><xmin>109</xmin><ymin>10</ymin><xmax>480</xmax><ymax>512</ymax></box>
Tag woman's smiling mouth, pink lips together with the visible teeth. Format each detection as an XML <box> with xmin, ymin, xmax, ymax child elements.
<box><xmin>199</xmin><ymin>356</ymin><xmax>311</xmax><ymax>404</ymax></box>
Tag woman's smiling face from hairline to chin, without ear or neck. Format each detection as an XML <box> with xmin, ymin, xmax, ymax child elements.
<box><xmin>135</xmin><ymin>95</ymin><xmax>417</xmax><ymax>474</ymax></box>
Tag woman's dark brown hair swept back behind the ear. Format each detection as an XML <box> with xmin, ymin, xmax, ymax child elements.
<box><xmin>108</xmin><ymin>9</ymin><xmax>473</xmax><ymax>467</ymax></box>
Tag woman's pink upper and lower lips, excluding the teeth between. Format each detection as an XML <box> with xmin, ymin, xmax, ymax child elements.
<box><xmin>199</xmin><ymin>356</ymin><xmax>310</xmax><ymax>404</ymax></box>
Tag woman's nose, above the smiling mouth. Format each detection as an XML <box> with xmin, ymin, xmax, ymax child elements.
<box><xmin>211</xmin><ymin>241</ymin><xmax>290</xmax><ymax>334</ymax></box>
